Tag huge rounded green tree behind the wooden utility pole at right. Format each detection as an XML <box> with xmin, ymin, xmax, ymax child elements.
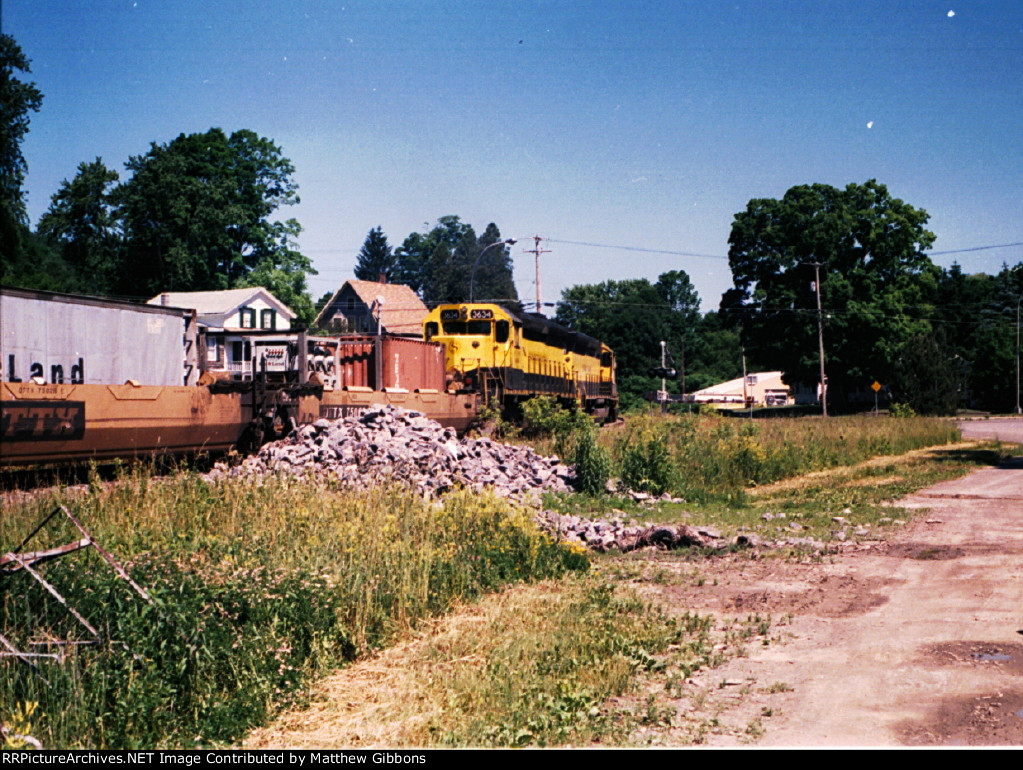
<box><xmin>721</xmin><ymin>179</ymin><xmax>940</xmax><ymax>404</ymax></box>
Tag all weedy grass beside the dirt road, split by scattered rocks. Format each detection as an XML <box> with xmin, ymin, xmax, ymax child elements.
<box><xmin>0</xmin><ymin>409</ymin><xmax>999</xmax><ymax>748</ymax></box>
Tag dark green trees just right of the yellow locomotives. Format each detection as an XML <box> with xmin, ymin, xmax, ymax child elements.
<box><xmin>555</xmin><ymin>270</ymin><xmax>700</xmax><ymax>401</ymax></box>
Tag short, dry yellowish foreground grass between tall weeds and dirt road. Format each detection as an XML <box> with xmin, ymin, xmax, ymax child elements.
<box><xmin>244</xmin><ymin>576</ymin><xmax>709</xmax><ymax>749</ymax></box>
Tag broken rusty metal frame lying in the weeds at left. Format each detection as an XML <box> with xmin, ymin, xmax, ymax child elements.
<box><xmin>0</xmin><ymin>505</ymin><xmax>152</xmax><ymax>673</ymax></box>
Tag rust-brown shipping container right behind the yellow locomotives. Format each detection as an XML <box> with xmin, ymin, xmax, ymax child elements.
<box><xmin>338</xmin><ymin>334</ymin><xmax>444</xmax><ymax>392</ymax></box>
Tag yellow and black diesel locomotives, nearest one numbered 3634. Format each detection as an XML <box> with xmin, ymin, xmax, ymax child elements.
<box><xmin>424</xmin><ymin>303</ymin><xmax>618</xmax><ymax>422</ymax></box>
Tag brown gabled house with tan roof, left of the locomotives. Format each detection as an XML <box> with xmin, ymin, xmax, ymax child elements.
<box><xmin>314</xmin><ymin>279</ymin><xmax>430</xmax><ymax>337</ymax></box>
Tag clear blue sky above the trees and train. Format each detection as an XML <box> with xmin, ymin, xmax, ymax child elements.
<box><xmin>2</xmin><ymin>0</ymin><xmax>1023</xmax><ymax>310</ymax></box>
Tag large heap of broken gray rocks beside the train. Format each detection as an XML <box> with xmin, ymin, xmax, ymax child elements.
<box><xmin>210</xmin><ymin>405</ymin><xmax>575</xmax><ymax>499</ymax></box>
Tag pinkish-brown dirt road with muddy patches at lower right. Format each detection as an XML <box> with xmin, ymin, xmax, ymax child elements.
<box><xmin>664</xmin><ymin>458</ymin><xmax>1023</xmax><ymax>745</ymax></box>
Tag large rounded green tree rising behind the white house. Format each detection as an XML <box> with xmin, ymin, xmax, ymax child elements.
<box><xmin>115</xmin><ymin>128</ymin><xmax>315</xmax><ymax>298</ymax></box>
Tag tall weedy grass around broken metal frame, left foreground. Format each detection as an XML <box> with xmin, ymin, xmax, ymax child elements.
<box><xmin>0</xmin><ymin>473</ymin><xmax>587</xmax><ymax>748</ymax></box>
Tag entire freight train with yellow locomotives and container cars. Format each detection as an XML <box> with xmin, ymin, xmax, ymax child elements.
<box><xmin>0</xmin><ymin>288</ymin><xmax>617</xmax><ymax>466</ymax></box>
